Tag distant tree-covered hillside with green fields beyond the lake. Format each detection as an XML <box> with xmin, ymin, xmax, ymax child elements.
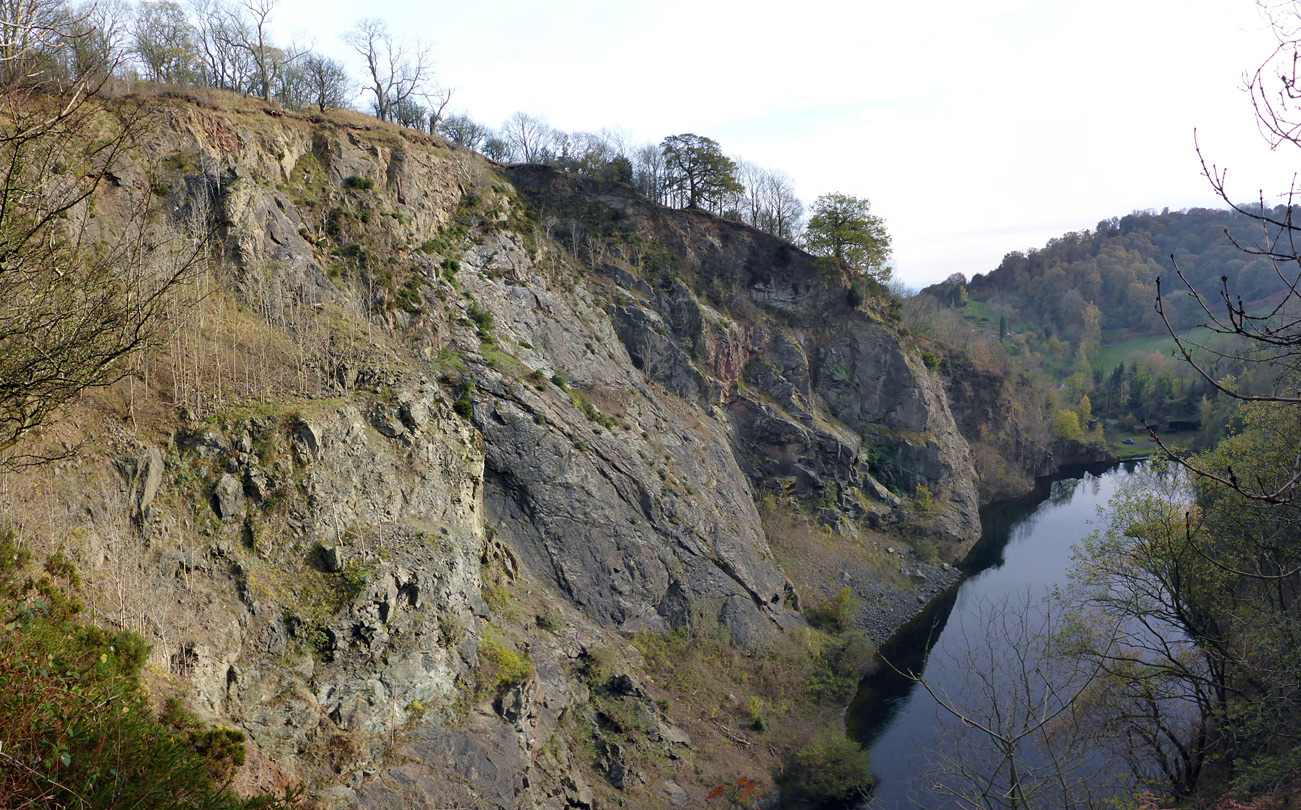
<box><xmin>909</xmin><ymin>205</ymin><xmax>1289</xmax><ymax>460</ymax></box>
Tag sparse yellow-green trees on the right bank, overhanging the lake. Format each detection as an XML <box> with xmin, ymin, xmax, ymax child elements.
<box><xmin>1071</xmin><ymin>416</ymin><xmax>1301</xmax><ymax>796</ymax></box>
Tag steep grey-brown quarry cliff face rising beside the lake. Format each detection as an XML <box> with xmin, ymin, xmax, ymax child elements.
<box><xmin>7</xmin><ymin>103</ymin><xmax>978</xmax><ymax>807</ymax></box>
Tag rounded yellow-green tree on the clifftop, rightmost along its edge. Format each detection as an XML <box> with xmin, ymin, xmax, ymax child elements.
<box><xmin>804</xmin><ymin>194</ymin><xmax>891</xmax><ymax>282</ymax></box>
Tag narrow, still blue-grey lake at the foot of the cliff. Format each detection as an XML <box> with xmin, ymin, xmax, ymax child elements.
<box><xmin>846</xmin><ymin>463</ymin><xmax>1136</xmax><ymax>810</ymax></box>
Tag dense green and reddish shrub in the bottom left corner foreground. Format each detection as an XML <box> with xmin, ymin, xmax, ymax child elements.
<box><xmin>0</xmin><ymin>530</ymin><xmax>290</xmax><ymax>810</ymax></box>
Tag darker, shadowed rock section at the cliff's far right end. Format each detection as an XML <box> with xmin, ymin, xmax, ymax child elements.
<box><xmin>511</xmin><ymin>166</ymin><xmax>980</xmax><ymax>547</ymax></box>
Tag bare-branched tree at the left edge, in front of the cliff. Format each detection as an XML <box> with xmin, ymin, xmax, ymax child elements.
<box><xmin>0</xmin><ymin>0</ymin><xmax>200</xmax><ymax>463</ymax></box>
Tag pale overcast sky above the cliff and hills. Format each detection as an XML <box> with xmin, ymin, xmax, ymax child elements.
<box><xmin>276</xmin><ymin>0</ymin><xmax>1301</xmax><ymax>285</ymax></box>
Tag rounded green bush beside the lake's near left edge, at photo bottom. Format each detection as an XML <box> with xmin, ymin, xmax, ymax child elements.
<box><xmin>779</xmin><ymin>729</ymin><xmax>872</xmax><ymax>807</ymax></box>
